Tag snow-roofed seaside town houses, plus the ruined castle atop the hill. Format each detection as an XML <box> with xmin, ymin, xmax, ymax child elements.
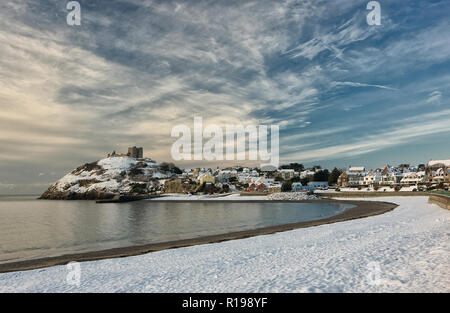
<box><xmin>108</xmin><ymin>147</ymin><xmax>450</xmax><ymax>195</ymax></box>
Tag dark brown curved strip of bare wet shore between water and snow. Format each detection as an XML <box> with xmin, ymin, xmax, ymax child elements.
<box><xmin>0</xmin><ymin>200</ymin><xmax>397</xmax><ymax>273</ymax></box>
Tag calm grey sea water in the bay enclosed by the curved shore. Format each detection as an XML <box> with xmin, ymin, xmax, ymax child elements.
<box><xmin>0</xmin><ymin>196</ymin><xmax>349</xmax><ymax>263</ymax></box>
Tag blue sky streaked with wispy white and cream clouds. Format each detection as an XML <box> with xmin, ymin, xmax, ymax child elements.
<box><xmin>0</xmin><ymin>0</ymin><xmax>450</xmax><ymax>194</ymax></box>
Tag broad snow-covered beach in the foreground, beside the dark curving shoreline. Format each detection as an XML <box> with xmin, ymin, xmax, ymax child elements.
<box><xmin>0</xmin><ymin>197</ymin><xmax>450</xmax><ymax>292</ymax></box>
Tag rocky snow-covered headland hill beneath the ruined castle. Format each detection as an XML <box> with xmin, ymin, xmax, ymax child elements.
<box><xmin>41</xmin><ymin>156</ymin><xmax>173</xmax><ymax>199</ymax></box>
